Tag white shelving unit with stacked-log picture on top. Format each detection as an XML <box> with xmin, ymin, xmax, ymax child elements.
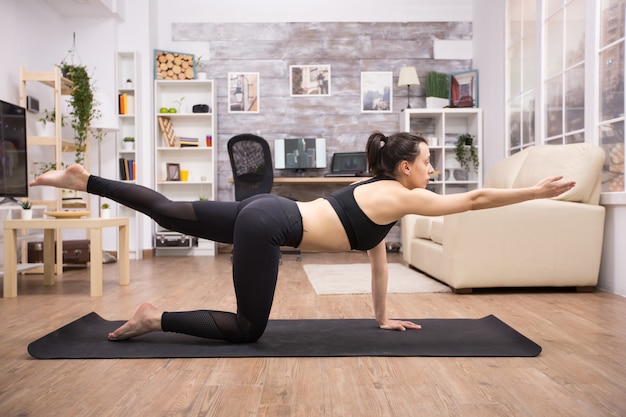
<box><xmin>154</xmin><ymin>80</ymin><xmax>217</xmax><ymax>256</ymax></box>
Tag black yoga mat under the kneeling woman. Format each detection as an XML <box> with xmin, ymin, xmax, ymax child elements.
<box><xmin>28</xmin><ymin>313</ymin><xmax>541</xmax><ymax>359</ymax></box>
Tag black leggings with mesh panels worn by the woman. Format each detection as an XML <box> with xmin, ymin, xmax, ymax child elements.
<box><xmin>87</xmin><ymin>175</ymin><xmax>303</xmax><ymax>342</ymax></box>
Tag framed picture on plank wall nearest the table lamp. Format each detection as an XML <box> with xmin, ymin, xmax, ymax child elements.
<box><xmin>361</xmin><ymin>71</ymin><xmax>393</xmax><ymax>113</ymax></box>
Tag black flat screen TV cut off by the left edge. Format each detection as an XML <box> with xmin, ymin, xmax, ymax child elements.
<box><xmin>0</xmin><ymin>100</ymin><xmax>28</xmax><ymax>204</ymax></box>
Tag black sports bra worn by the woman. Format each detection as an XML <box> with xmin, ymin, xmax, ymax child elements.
<box><xmin>326</xmin><ymin>176</ymin><xmax>396</xmax><ymax>250</ymax></box>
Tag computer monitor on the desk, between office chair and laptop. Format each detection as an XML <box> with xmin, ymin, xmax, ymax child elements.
<box><xmin>274</xmin><ymin>138</ymin><xmax>326</xmax><ymax>170</ymax></box>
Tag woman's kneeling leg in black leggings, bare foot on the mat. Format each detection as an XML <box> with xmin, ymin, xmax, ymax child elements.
<box><xmin>109</xmin><ymin>196</ymin><xmax>302</xmax><ymax>342</ymax></box>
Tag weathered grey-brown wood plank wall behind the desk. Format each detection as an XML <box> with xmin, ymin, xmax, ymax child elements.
<box><xmin>172</xmin><ymin>22</ymin><xmax>472</xmax><ymax>241</ymax></box>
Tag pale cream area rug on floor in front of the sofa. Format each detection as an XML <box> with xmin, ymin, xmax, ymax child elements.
<box><xmin>302</xmin><ymin>263</ymin><xmax>451</xmax><ymax>295</ymax></box>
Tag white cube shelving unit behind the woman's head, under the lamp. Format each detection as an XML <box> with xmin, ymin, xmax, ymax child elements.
<box><xmin>399</xmin><ymin>108</ymin><xmax>483</xmax><ymax>194</ymax></box>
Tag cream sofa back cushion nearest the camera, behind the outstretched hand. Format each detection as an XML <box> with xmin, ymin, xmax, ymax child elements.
<box><xmin>507</xmin><ymin>143</ymin><xmax>604</xmax><ymax>203</ymax></box>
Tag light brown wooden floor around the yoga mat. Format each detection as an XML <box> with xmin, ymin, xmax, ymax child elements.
<box><xmin>0</xmin><ymin>253</ymin><xmax>626</xmax><ymax>417</ymax></box>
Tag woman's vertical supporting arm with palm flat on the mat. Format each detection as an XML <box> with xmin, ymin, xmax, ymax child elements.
<box><xmin>367</xmin><ymin>240</ymin><xmax>421</xmax><ymax>331</ymax></box>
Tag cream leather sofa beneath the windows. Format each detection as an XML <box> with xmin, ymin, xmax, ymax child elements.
<box><xmin>402</xmin><ymin>143</ymin><xmax>604</xmax><ymax>292</ymax></box>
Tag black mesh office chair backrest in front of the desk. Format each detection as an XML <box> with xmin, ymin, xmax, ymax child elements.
<box><xmin>227</xmin><ymin>134</ymin><xmax>274</xmax><ymax>201</ymax></box>
